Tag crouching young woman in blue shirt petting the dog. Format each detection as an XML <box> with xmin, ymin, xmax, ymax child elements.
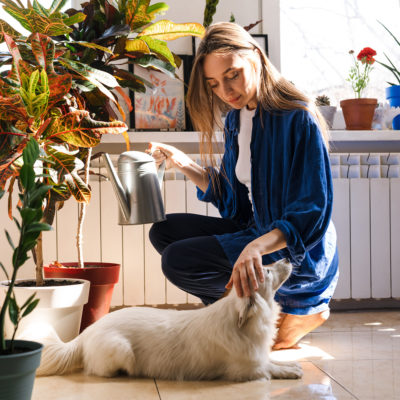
<box><xmin>150</xmin><ymin>23</ymin><xmax>338</xmax><ymax>349</ymax></box>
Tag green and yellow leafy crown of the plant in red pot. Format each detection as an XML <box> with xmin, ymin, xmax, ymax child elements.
<box><xmin>0</xmin><ymin>0</ymin><xmax>204</xmax><ymax>120</ymax></box>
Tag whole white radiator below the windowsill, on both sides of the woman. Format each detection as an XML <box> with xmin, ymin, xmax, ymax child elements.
<box><xmin>0</xmin><ymin>154</ymin><xmax>400</xmax><ymax>306</ymax></box>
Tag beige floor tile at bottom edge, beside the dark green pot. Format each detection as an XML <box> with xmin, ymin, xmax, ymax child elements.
<box><xmin>32</xmin><ymin>373</ymin><xmax>159</xmax><ymax>400</ymax></box>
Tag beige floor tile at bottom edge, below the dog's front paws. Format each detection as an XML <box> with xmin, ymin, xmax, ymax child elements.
<box><xmin>156</xmin><ymin>362</ymin><xmax>355</xmax><ymax>400</ymax></box>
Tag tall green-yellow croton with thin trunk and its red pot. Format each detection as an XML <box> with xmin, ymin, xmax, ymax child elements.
<box><xmin>1</xmin><ymin>0</ymin><xmax>204</xmax><ymax>330</ymax></box>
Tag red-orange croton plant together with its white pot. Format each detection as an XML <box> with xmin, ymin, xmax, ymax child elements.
<box><xmin>0</xmin><ymin>24</ymin><xmax>127</xmax><ymax>340</ymax></box>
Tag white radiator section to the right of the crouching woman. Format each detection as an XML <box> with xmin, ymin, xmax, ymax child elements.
<box><xmin>331</xmin><ymin>154</ymin><xmax>400</xmax><ymax>299</ymax></box>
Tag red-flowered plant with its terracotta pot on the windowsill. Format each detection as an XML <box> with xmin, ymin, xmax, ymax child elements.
<box><xmin>340</xmin><ymin>47</ymin><xmax>378</xmax><ymax>130</ymax></box>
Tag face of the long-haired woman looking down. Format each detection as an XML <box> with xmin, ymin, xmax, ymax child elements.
<box><xmin>203</xmin><ymin>52</ymin><xmax>259</xmax><ymax>109</ymax></box>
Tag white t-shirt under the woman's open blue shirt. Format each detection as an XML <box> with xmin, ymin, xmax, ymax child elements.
<box><xmin>235</xmin><ymin>107</ymin><xmax>256</xmax><ymax>204</ymax></box>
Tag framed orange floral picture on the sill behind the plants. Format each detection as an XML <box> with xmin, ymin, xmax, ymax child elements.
<box><xmin>131</xmin><ymin>56</ymin><xmax>192</xmax><ymax>131</ymax></box>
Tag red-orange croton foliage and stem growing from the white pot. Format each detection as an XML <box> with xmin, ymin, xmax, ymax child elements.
<box><xmin>0</xmin><ymin>33</ymin><xmax>127</xmax><ymax>285</ymax></box>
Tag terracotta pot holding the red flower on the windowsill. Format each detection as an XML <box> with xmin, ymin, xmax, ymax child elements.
<box><xmin>340</xmin><ymin>98</ymin><xmax>378</xmax><ymax>130</ymax></box>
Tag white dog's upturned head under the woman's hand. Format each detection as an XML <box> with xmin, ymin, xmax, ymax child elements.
<box><xmin>238</xmin><ymin>259</ymin><xmax>292</xmax><ymax>328</ymax></box>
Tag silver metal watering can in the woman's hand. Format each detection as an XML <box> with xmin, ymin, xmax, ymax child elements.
<box><xmin>103</xmin><ymin>151</ymin><xmax>166</xmax><ymax>225</ymax></box>
